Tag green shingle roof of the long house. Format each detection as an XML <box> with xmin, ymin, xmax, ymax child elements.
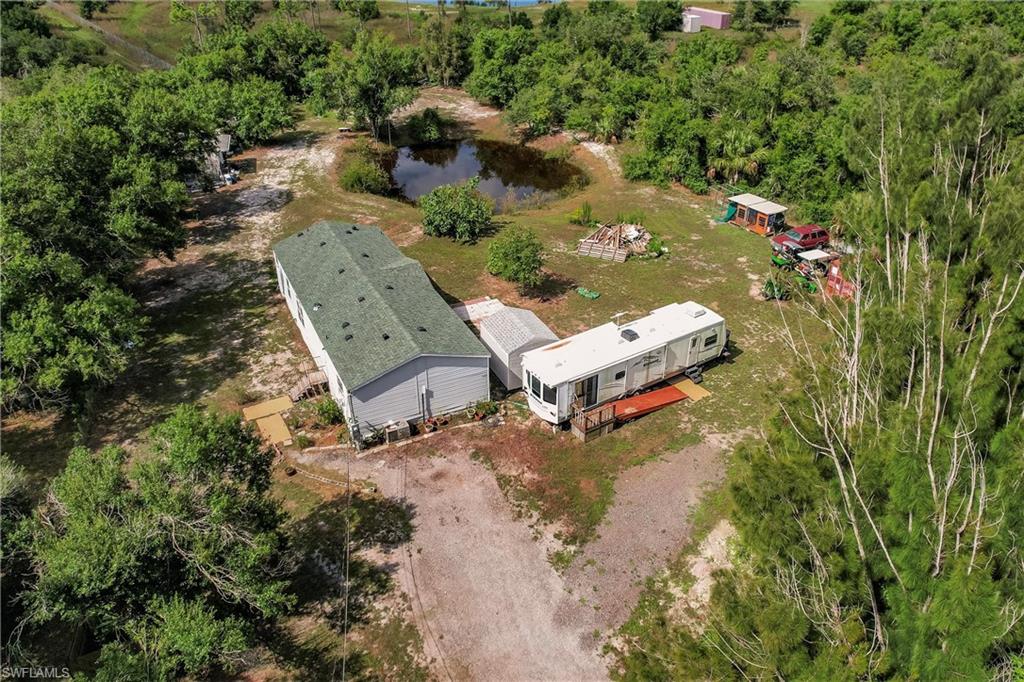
<box><xmin>273</xmin><ymin>221</ymin><xmax>487</xmax><ymax>391</ymax></box>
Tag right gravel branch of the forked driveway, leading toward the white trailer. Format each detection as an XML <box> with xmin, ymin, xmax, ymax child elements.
<box><xmin>565</xmin><ymin>438</ymin><xmax>724</xmax><ymax>631</ymax></box>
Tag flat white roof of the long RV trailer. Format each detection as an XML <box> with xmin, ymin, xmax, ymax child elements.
<box><xmin>522</xmin><ymin>301</ymin><xmax>723</xmax><ymax>386</ymax></box>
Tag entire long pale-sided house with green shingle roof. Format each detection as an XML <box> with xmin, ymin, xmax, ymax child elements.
<box><xmin>273</xmin><ymin>221</ymin><xmax>489</xmax><ymax>442</ymax></box>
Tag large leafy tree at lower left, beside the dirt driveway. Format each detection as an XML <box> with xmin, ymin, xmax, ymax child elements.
<box><xmin>29</xmin><ymin>407</ymin><xmax>293</xmax><ymax>679</ymax></box>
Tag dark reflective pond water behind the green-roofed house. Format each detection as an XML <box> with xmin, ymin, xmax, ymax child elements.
<box><xmin>386</xmin><ymin>139</ymin><xmax>586</xmax><ymax>203</ymax></box>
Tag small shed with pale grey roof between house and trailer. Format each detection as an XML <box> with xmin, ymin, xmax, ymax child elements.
<box><xmin>479</xmin><ymin>307</ymin><xmax>558</xmax><ymax>391</ymax></box>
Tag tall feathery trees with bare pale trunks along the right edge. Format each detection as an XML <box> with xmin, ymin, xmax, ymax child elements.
<box><xmin>622</xmin><ymin>3</ymin><xmax>1024</xmax><ymax>680</ymax></box>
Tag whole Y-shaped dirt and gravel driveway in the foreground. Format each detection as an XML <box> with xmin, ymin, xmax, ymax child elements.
<box><xmin>299</xmin><ymin>427</ymin><xmax>723</xmax><ymax>681</ymax></box>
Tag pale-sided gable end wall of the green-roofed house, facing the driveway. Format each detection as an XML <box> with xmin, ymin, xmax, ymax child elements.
<box><xmin>351</xmin><ymin>355</ymin><xmax>490</xmax><ymax>429</ymax></box>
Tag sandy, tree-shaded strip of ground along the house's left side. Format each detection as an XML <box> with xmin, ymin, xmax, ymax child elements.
<box><xmin>90</xmin><ymin>134</ymin><xmax>336</xmax><ymax>445</ymax></box>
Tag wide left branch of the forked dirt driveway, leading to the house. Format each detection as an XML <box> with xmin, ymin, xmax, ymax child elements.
<box><xmin>303</xmin><ymin>439</ymin><xmax>607</xmax><ymax>682</ymax></box>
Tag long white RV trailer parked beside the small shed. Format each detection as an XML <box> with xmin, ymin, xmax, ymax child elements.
<box><xmin>522</xmin><ymin>301</ymin><xmax>728</xmax><ymax>424</ymax></box>
